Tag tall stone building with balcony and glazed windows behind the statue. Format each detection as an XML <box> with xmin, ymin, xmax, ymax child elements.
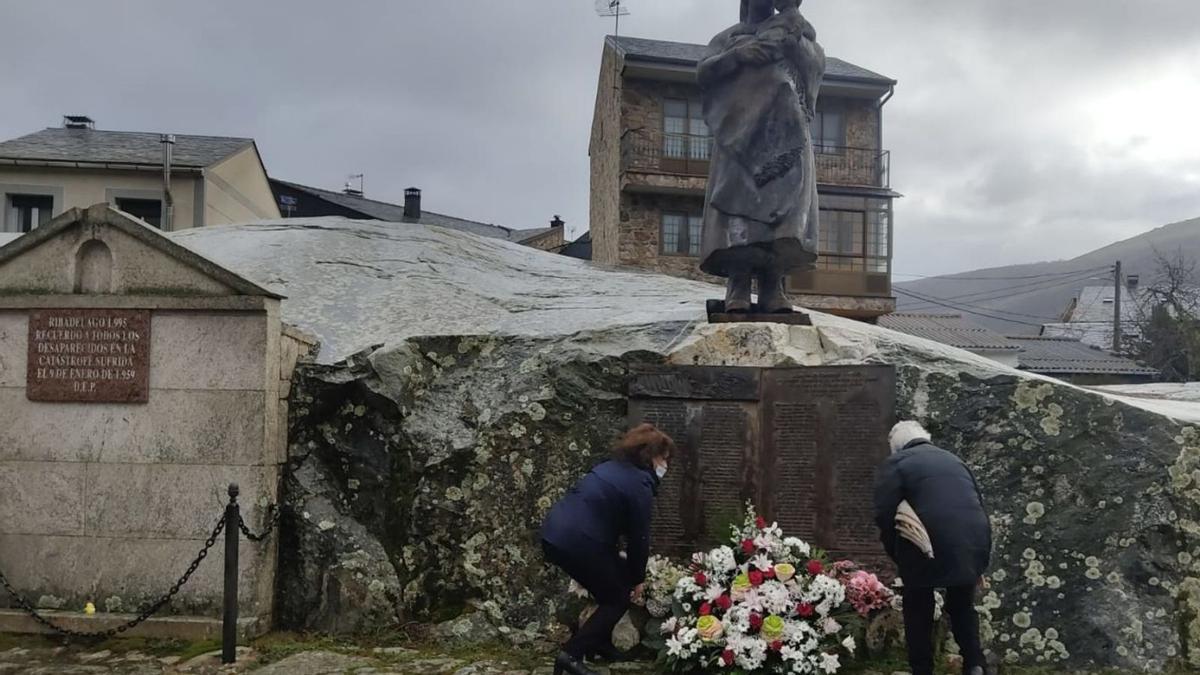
<box><xmin>589</xmin><ymin>36</ymin><xmax>899</xmax><ymax>321</ymax></box>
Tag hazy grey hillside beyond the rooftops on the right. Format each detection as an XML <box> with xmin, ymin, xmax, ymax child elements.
<box><xmin>895</xmin><ymin>219</ymin><xmax>1200</xmax><ymax>334</ymax></box>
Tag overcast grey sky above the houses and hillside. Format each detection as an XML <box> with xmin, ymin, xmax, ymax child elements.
<box><xmin>0</xmin><ymin>0</ymin><xmax>1200</xmax><ymax>274</ymax></box>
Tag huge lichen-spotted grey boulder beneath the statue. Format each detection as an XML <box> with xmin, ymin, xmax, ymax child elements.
<box><xmin>181</xmin><ymin>219</ymin><xmax>1200</xmax><ymax>670</ymax></box>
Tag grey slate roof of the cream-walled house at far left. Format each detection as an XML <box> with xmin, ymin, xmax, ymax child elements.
<box><xmin>0</xmin><ymin>129</ymin><xmax>254</xmax><ymax>168</ymax></box>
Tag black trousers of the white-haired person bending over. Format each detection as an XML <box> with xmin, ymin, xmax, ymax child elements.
<box><xmin>902</xmin><ymin>586</ymin><xmax>988</xmax><ymax>675</ymax></box>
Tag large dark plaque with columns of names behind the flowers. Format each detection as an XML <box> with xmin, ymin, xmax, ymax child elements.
<box><xmin>629</xmin><ymin>366</ymin><xmax>895</xmax><ymax>563</ymax></box>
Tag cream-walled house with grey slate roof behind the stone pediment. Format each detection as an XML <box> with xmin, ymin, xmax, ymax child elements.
<box><xmin>0</xmin><ymin>115</ymin><xmax>280</xmax><ymax>233</ymax></box>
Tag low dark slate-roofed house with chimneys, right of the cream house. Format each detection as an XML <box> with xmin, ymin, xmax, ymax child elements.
<box><xmin>270</xmin><ymin>178</ymin><xmax>566</xmax><ymax>251</ymax></box>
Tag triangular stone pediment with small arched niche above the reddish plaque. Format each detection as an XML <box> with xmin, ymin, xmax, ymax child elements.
<box><xmin>0</xmin><ymin>204</ymin><xmax>280</xmax><ymax>298</ymax></box>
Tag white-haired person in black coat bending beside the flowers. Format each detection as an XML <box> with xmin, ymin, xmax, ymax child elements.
<box><xmin>875</xmin><ymin>422</ymin><xmax>991</xmax><ymax>675</ymax></box>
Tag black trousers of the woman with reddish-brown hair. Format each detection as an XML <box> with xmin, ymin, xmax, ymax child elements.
<box><xmin>541</xmin><ymin>540</ymin><xmax>632</xmax><ymax>658</ymax></box>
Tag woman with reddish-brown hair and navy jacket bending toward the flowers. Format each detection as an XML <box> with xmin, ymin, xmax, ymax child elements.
<box><xmin>541</xmin><ymin>424</ymin><xmax>676</xmax><ymax>675</ymax></box>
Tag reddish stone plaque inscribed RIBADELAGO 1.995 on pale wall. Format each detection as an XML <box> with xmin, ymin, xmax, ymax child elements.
<box><xmin>25</xmin><ymin>309</ymin><xmax>150</xmax><ymax>402</ymax></box>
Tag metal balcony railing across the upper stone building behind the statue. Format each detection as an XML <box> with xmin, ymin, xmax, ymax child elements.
<box><xmin>620</xmin><ymin>133</ymin><xmax>892</xmax><ymax>187</ymax></box>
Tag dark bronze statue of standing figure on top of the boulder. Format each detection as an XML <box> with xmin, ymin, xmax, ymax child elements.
<box><xmin>698</xmin><ymin>0</ymin><xmax>824</xmax><ymax>313</ymax></box>
